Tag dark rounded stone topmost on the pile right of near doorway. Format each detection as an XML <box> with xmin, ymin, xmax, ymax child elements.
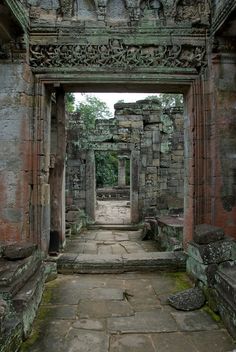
<box><xmin>193</xmin><ymin>224</ymin><xmax>225</xmax><ymax>244</ymax></box>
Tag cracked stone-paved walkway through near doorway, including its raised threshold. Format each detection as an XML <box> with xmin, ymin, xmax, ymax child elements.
<box><xmin>20</xmin><ymin>225</ymin><xmax>235</xmax><ymax>352</ymax></box>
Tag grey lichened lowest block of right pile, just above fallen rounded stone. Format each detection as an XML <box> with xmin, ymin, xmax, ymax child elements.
<box><xmin>186</xmin><ymin>257</ymin><xmax>218</xmax><ymax>287</ymax></box>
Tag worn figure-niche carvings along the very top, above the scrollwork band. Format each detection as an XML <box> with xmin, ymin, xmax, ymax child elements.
<box><xmin>56</xmin><ymin>0</ymin><xmax>210</xmax><ymax>25</ymax></box>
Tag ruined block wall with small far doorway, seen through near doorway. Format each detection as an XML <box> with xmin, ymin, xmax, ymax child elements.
<box><xmin>67</xmin><ymin>100</ymin><xmax>184</xmax><ymax>223</ymax></box>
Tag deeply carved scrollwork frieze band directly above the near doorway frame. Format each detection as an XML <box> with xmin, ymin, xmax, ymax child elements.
<box><xmin>30</xmin><ymin>39</ymin><xmax>206</xmax><ymax>71</ymax></box>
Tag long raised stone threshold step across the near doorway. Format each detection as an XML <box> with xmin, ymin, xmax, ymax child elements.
<box><xmin>57</xmin><ymin>252</ymin><xmax>186</xmax><ymax>274</ymax></box>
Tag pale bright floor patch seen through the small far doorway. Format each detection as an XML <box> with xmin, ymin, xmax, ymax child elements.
<box><xmin>96</xmin><ymin>200</ymin><xmax>130</xmax><ymax>224</ymax></box>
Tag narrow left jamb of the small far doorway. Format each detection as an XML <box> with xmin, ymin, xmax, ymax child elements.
<box><xmin>85</xmin><ymin>150</ymin><xmax>96</xmax><ymax>220</ymax></box>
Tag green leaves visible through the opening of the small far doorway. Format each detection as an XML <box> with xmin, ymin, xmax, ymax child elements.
<box><xmin>95</xmin><ymin>152</ymin><xmax>118</xmax><ymax>188</ymax></box>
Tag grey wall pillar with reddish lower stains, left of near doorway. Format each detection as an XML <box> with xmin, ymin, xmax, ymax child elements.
<box><xmin>0</xmin><ymin>58</ymin><xmax>36</xmax><ymax>242</ymax></box>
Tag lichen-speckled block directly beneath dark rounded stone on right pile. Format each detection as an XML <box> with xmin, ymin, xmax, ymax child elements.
<box><xmin>187</xmin><ymin>240</ymin><xmax>232</xmax><ymax>264</ymax></box>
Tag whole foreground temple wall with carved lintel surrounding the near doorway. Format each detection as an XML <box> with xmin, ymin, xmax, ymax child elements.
<box><xmin>0</xmin><ymin>0</ymin><xmax>236</xmax><ymax>351</ymax></box>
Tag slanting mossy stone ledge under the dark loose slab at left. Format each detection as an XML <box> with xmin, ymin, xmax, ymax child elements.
<box><xmin>0</xmin><ymin>251</ymin><xmax>42</xmax><ymax>300</ymax></box>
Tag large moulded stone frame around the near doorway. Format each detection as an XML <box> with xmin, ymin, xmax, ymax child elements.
<box><xmin>33</xmin><ymin>72</ymin><xmax>208</xmax><ymax>248</ymax></box>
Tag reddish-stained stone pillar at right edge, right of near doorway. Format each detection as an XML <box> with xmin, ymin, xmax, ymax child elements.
<box><xmin>209</xmin><ymin>53</ymin><xmax>236</xmax><ymax>238</ymax></box>
